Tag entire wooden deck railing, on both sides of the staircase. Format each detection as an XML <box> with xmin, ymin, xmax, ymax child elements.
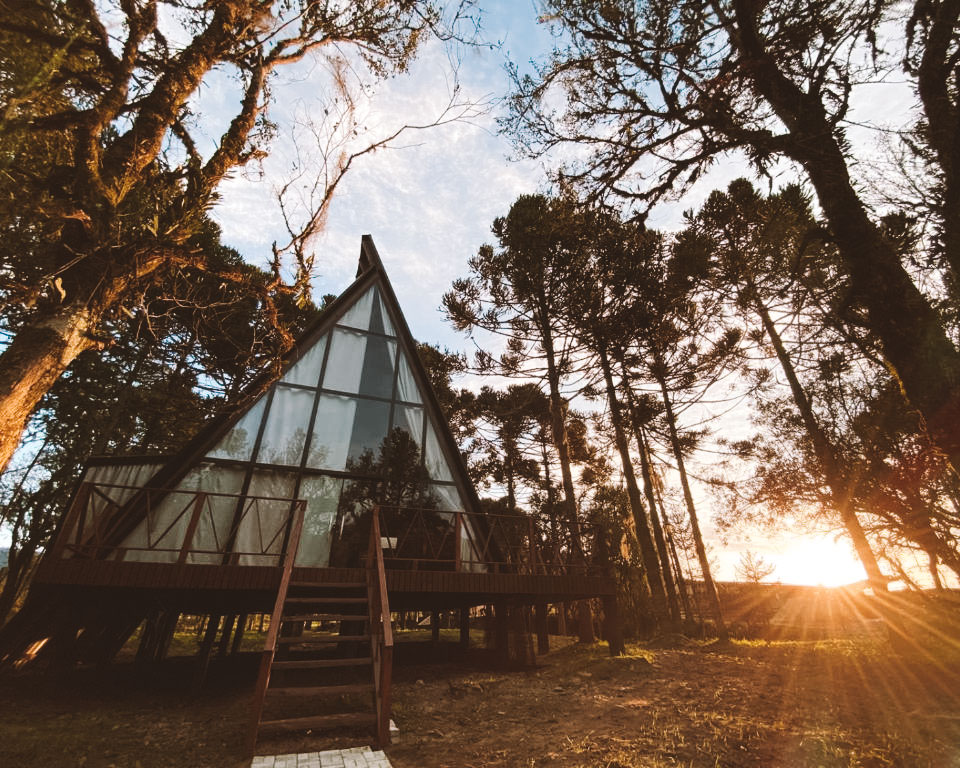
<box><xmin>49</xmin><ymin>482</ymin><xmax>608</xmax><ymax>576</ymax></box>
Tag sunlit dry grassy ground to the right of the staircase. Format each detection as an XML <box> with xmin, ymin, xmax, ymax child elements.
<box><xmin>392</xmin><ymin>641</ymin><xmax>960</xmax><ymax>768</ymax></box>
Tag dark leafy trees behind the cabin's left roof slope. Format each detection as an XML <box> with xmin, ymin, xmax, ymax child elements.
<box><xmin>0</xmin><ymin>224</ymin><xmax>317</xmax><ymax>623</ymax></box>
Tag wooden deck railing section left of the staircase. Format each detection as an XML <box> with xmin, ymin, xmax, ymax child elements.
<box><xmin>50</xmin><ymin>482</ymin><xmax>306</xmax><ymax>565</ymax></box>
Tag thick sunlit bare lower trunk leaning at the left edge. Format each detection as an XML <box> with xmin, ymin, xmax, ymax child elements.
<box><xmin>0</xmin><ymin>303</ymin><xmax>95</xmax><ymax>472</ymax></box>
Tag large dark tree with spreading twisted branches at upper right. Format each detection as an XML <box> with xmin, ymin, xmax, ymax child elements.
<box><xmin>504</xmin><ymin>0</ymin><xmax>960</xmax><ymax>474</ymax></box>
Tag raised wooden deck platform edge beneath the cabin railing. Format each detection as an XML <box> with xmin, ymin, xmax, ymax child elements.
<box><xmin>35</xmin><ymin>559</ymin><xmax>615</xmax><ymax>612</ymax></box>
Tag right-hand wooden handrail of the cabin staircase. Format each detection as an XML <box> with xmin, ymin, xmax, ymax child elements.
<box><xmin>367</xmin><ymin>507</ymin><xmax>393</xmax><ymax>748</ymax></box>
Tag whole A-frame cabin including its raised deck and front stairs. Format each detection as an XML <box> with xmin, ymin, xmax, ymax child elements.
<box><xmin>0</xmin><ymin>236</ymin><xmax>614</xmax><ymax>743</ymax></box>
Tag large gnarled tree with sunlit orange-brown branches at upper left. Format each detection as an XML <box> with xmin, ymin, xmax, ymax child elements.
<box><xmin>0</xmin><ymin>0</ymin><xmax>472</xmax><ymax>469</ymax></box>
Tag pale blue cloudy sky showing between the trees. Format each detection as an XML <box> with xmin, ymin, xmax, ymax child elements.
<box><xmin>206</xmin><ymin>0</ymin><xmax>928</xmax><ymax>585</ymax></box>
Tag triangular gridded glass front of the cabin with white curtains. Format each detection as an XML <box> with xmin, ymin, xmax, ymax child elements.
<box><xmin>118</xmin><ymin>284</ymin><xmax>464</xmax><ymax>567</ymax></box>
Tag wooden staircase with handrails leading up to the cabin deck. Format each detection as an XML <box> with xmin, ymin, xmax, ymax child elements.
<box><xmin>248</xmin><ymin>511</ymin><xmax>393</xmax><ymax>754</ymax></box>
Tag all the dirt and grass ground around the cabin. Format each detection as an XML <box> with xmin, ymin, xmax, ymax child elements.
<box><xmin>0</xmin><ymin>638</ymin><xmax>960</xmax><ymax>768</ymax></box>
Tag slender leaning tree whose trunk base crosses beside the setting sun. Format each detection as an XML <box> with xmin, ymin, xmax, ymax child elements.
<box><xmin>679</xmin><ymin>179</ymin><xmax>887</xmax><ymax>590</ymax></box>
